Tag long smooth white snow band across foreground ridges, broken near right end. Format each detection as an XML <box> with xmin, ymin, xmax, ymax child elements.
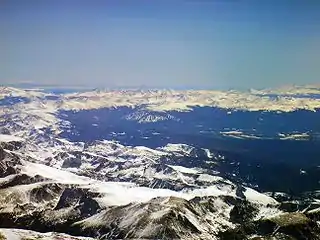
<box><xmin>18</xmin><ymin>161</ymin><xmax>277</xmax><ymax>206</ymax></box>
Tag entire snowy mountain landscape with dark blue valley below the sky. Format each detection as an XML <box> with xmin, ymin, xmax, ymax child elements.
<box><xmin>0</xmin><ymin>86</ymin><xmax>320</xmax><ymax>240</ymax></box>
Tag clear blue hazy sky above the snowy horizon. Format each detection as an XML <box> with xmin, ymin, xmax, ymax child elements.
<box><xmin>0</xmin><ymin>0</ymin><xmax>320</xmax><ymax>89</ymax></box>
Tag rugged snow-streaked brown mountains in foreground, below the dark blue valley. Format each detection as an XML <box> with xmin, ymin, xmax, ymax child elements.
<box><xmin>0</xmin><ymin>135</ymin><xmax>320</xmax><ymax>239</ymax></box>
